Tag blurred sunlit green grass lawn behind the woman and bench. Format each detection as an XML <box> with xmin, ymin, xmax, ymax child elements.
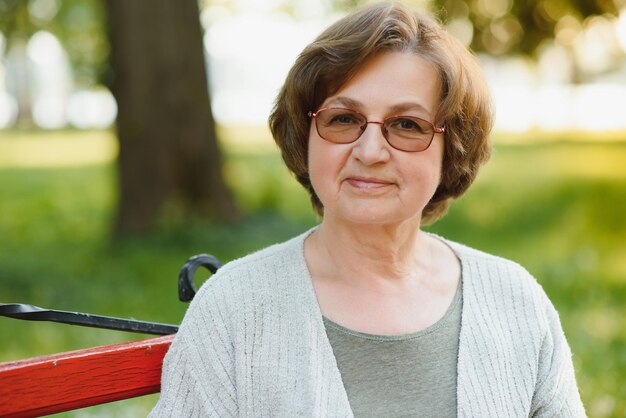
<box><xmin>0</xmin><ymin>131</ymin><xmax>626</xmax><ymax>417</ymax></box>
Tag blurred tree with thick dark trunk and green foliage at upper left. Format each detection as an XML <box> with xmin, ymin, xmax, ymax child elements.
<box><xmin>0</xmin><ymin>0</ymin><xmax>235</xmax><ymax>232</ymax></box>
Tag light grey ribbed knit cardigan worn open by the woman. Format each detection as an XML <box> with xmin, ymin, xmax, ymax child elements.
<box><xmin>150</xmin><ymin>231</ymin><xmax>585</xmax><ymax>418</ymax></box>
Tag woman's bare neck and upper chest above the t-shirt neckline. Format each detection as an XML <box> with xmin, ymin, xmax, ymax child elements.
<box><xmin>304</xmin><ymin>218</ymin><xmax>460</xmax><ymax>334</ymax></box>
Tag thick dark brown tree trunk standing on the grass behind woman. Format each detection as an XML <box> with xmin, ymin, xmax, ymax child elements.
<box><xmin>104</xmin><ymin>0</ymin><xmax>235</xmax><ymax>233</ymax></box>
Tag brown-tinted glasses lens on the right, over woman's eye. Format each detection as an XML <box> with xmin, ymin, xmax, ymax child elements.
<box><xmin>385</xmin><ymin>116</ymin><xmax>435</xmax><ymax>152</ymax></box>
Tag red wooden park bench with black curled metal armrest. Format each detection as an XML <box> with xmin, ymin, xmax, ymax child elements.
<box><xmin>0</xmin><ymin>254</ymin><xmax>220</xmax><ymax>418</ymax></box>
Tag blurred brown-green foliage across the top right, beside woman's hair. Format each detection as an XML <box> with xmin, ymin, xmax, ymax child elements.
<box><xmin>320</xmin><ymin>0</ymin><xmax>625</xmax><ymax>83</ymax></box>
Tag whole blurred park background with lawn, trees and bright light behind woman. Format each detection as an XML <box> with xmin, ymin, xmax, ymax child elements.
<box><xmin>0</xmin><ymin>0</ymin><xmax>626</xmax><ymax>417</ymax></box>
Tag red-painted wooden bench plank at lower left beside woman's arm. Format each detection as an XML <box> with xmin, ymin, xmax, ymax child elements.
<box><xmin>0</xmin><ymin>335</ymin><xmax>174</xmax><ymax>417</ymax></box>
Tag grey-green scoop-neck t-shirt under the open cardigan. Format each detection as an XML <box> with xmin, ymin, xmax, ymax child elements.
<box><xmin>324</xmin><ymin>284</ymin><xmax>463</xmax><ymax>418</ymax></box>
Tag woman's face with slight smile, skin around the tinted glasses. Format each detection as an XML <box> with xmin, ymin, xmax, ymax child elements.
<box><xmin>309</xmin><ymin>52</ymin><xmax>443</xmax><ymax>226</ymax></box>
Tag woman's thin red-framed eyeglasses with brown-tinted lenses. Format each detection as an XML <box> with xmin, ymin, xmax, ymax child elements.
<box><xmin>308</xmin><ymin>107</ymin><xmax>445</xmax><ymax>152</ymax></box>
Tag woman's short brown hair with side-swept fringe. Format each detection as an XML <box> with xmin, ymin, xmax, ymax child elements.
<box><xmin>269</xmin><ymin>3</ymin><xmax>493</xmax><ymax>224</ymax></box>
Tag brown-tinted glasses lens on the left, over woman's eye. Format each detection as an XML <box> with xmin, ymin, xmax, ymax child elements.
<box><xmin>315</xmin><ymin>108</ymin><xmax>367</xmax><ymax>144</ymax></box>
